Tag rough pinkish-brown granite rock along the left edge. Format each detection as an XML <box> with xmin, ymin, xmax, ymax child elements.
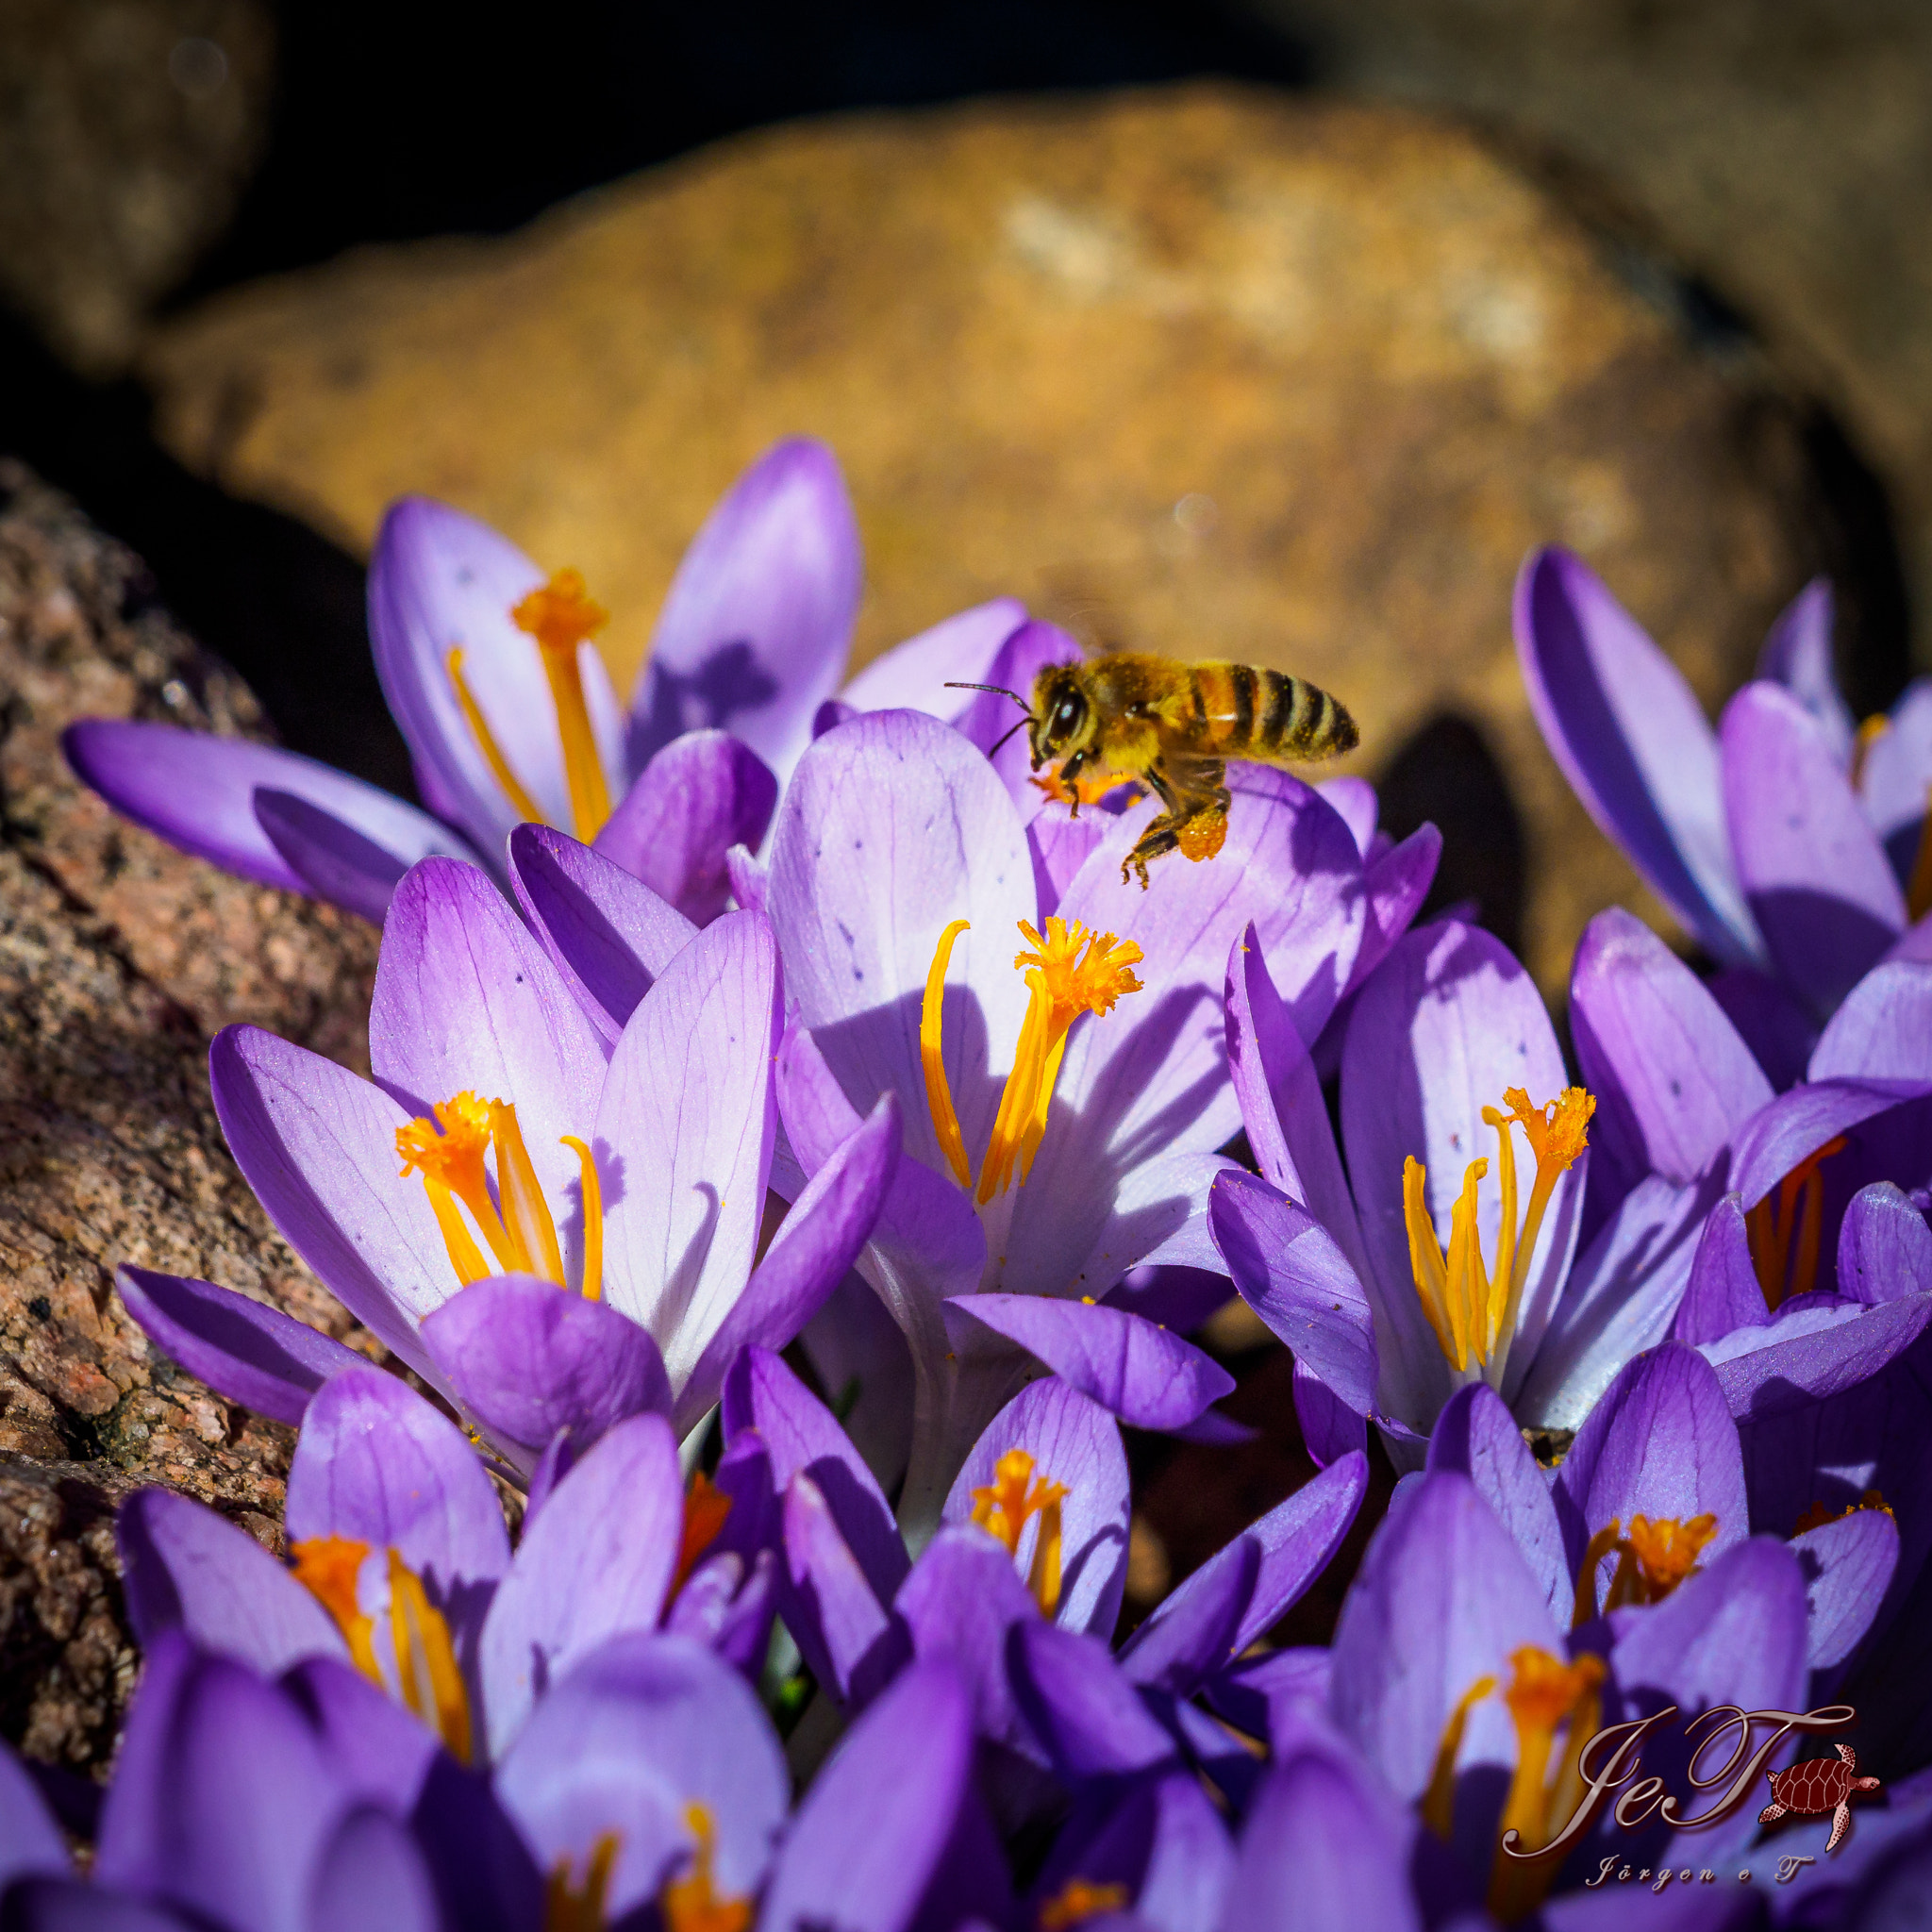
<box><xmin>0</xmin><ymin>461</ymin><xmax>375</xmax><ymax>1768</ymax></box>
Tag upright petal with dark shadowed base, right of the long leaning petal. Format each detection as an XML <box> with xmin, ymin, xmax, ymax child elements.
<box><xmin>1720</xmin><ymin>684</ymin><xmax>1905</xmax><ymax>1016</ymax></box>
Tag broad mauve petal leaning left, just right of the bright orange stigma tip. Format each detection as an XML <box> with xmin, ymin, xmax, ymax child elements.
<box><xmin>1571</xmin><ymin>907</ymin><xmax>1772</xmax><ymax>1182</ymax></box>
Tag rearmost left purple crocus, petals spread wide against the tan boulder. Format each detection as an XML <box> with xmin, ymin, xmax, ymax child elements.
<box><xmin>66</xmin><ymin>437</ymin><xmax>1024</xmax><ymax>924</ymax></box>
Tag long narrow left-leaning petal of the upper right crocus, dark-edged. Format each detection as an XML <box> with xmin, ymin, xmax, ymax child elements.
<box><xmin>1515</xmin><ymin>549</ymin><xmax>1762</xmax><ymax>964</ymax></box>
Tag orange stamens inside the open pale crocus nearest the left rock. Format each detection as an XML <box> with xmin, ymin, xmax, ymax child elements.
<box><xmin>396</xmin><ymin>1091</ymin><xmax>603</xmax><ymax>1300</ymax></box>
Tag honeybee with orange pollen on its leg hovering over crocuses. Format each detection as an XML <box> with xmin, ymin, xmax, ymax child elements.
<box><xmin>958</xmin><ymin>651</ymin><xmax>1358</xmax><ymax>891</ymax></box>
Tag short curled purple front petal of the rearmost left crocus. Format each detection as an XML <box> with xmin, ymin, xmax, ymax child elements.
<box><xmin>595</xmin><ymin>730</ymin><xmax>778</xmax><ymax>925</ymax></box>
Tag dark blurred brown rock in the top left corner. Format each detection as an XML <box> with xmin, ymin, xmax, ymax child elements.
<box><xmin>0</xmin><ymin>0</ymin><xmax>275</xmax><ymax>375</ymax></box>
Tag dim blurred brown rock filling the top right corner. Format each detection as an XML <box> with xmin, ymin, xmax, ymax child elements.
<box><xmin>1244</xmin><ymin>0</ymin><xmax>1932</xmax><ymax>665</ymax></box>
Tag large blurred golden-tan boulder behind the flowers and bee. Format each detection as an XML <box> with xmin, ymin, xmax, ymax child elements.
<box><xmin>145</xmin><ymin>87</ymin><xmax>1820</xmax><ymax>983</ymax></box>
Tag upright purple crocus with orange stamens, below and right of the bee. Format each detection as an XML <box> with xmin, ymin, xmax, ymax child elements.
<box><xmin>1211</xmin><ymin>920</ymin><xmax>1661</xmax><ymax>1462</ymax></box>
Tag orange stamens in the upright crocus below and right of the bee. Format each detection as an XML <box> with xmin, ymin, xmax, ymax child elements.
<box><xmin>1403</xmin><ymin>1088</ymin><xmax>1596</xmax><ymax>1383</ymax></box>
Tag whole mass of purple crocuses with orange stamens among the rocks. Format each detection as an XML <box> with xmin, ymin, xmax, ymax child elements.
<box><xmin>26</xmin><ymin>442</ymin><xmax>1932</xmax><ymax>1932</ymax></box>
